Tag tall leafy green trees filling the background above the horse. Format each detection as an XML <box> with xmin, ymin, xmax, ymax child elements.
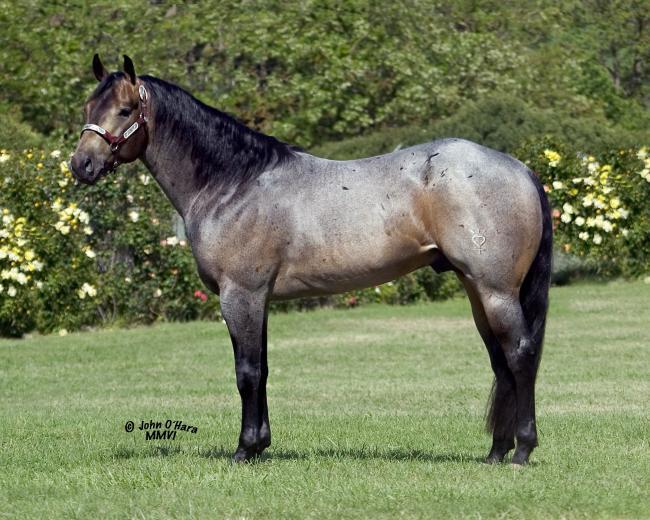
<box><xmin>0</xmin><ymin>0</ymin><xmax>650</xmax><ymax>146</ymax></box>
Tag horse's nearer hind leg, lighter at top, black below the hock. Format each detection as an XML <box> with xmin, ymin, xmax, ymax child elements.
<box><xmin>476</xmin><ymin>285</ymin><xmax>541</xmax><ymax>464</ymax></box>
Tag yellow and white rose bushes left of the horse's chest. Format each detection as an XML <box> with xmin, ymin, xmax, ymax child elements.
<box><xmin>0</xmin><ymin>150</ymin><xmax>218</xmax><ymax>336</ymax></box>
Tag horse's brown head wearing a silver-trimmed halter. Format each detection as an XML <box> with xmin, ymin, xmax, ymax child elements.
<box><xmin>70</xmin><ymin>54</ymin><xmax>148</xmax><ymax>184</ymax></box>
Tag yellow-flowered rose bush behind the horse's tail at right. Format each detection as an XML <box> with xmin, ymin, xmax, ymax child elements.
<box><xmin>526</xmin><ymin>138</ymin><xmax>650</xmax><ymax>275</ymax></box>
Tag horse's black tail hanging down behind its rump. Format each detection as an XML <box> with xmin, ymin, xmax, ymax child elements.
<box><xmin>519</xmin><ymin>172</ymin><xmax>553</xmax><ymax>365</ymax></box>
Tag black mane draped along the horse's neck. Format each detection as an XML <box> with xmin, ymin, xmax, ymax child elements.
<box><xmin>140</xmin><ymin>76</ymin><xmax>300</xmax><ymax>190</ymax></box>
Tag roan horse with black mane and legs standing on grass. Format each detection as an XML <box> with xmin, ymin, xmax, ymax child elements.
<box><xmin>70</xmin><ymin>54</ymin><xmax>552</xmax><ymax>465</ymax></box>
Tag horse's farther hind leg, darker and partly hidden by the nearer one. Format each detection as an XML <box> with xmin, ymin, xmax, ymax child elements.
<box><xmin>459</xmin><ymin>274</ymin><xmax>517</xmax><ymax>464</ymax></box>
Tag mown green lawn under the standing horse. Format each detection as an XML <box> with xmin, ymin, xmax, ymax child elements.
<box><xmin>0</xmin><ymin>283</ymin><xmax>650</xmax><ymax>519</ymax></box>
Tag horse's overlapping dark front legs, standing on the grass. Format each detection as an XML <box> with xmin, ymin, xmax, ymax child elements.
<box><xmin>221</xmin><ymin>287</ymin><xmax>271</xmax><ymax>462</ymax></box>
